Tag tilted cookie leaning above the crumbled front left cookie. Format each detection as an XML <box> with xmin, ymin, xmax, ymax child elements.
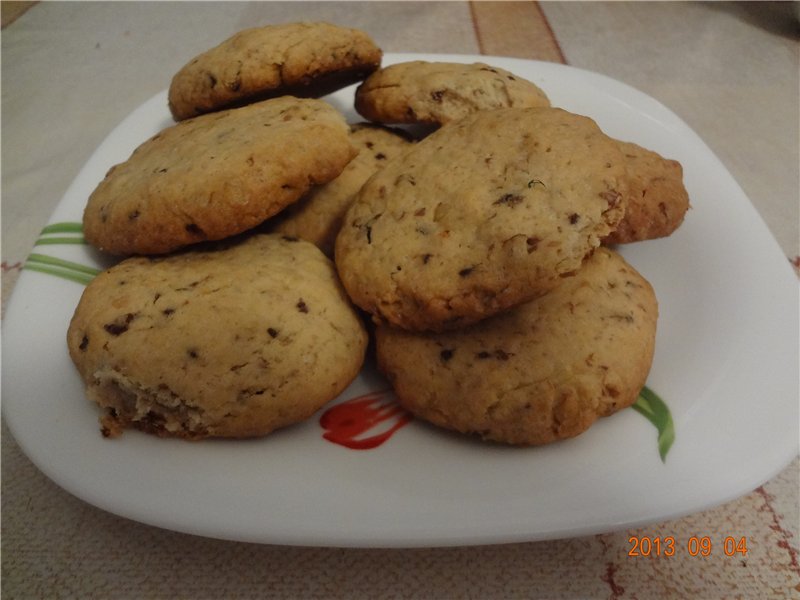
<box><xmin>83</xmin><ymin>96</ymin><xmax>357</xmax><ymax>255</ymax></box>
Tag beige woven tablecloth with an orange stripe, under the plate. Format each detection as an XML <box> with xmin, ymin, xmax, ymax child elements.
<box><xmin>1</xmin><ymin>2</ymin><xmax>800</xmax><ymax>598</ymax></box>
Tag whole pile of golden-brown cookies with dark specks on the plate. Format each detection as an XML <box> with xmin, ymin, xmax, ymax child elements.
<box><xmin>68</xmin><ymin>23</ymin><xmax>688</xmax><ymax>445</ymax></box>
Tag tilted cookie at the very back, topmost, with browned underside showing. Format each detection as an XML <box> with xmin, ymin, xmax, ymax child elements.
<box><xmin>168</xmin><ymin>23</ymin><xmax>383</xmax><ymax>121</ymax></box>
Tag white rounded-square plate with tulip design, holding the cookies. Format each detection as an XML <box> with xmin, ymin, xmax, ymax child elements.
<box><xmin>3</xmin><ymin>54</ymin><xmax>798</xmax><ymax>546</ymax></box>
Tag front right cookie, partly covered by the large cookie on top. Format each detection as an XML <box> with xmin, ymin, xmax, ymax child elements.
<box><xmin>376</xmin><ymin>248</ymin><xmax>658</xmax><ymax>445</ymax></box>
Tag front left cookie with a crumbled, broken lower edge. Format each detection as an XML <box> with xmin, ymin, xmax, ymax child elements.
<box><xmin>67</xmin><ymin>235</ymin><xmax>367</xmax><ymax>439</ymax></box>
